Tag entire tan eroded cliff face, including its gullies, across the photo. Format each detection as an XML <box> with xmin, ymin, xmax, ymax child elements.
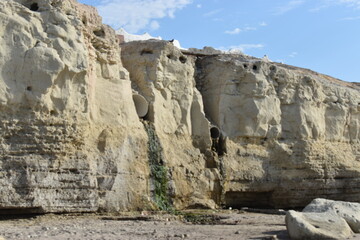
<box><xmin>0</xmin><ymin>0</ymin><xmax>360</xmax><ymax>212</ymax></box>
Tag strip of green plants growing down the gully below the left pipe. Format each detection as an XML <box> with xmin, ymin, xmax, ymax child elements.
<box><xmin>143</xmin><ymin>121</ymin><xmax>172</xmax><ymax>211</ymax></box>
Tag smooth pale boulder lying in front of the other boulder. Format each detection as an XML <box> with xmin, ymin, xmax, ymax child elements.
<box><xmin>285</xmin><ymin>210</ymin><xmax>353</xmax><ymax>240</ymax></box>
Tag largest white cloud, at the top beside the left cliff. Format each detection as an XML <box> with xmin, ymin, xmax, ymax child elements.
<box><xmin>97</xmin><ymin>0</ymin><xmax>192</xmax><ymax>33</ymax></box>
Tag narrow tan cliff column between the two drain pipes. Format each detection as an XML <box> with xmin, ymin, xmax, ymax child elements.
<box><xmin>121</xmin><ymin>40</ymin><xmax>220</xmax><ymax>208</ymax></box>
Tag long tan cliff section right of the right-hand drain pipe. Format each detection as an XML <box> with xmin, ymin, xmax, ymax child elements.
<box><xmin>197</xmin><ymin>55</ymin><xmax>360</xmax><ymax>207</ymax></box>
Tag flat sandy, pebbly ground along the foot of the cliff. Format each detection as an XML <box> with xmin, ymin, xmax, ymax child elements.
<box><xmin>0</xmin><ymin>210</ymin><xmax>358</xmax><ymax>240</ymax></box>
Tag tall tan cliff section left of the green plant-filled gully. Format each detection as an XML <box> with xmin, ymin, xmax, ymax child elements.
<box><xmin>0</xmin><ymin>0</ymin><xmax>148</xmax><ymax>212</ymax></box>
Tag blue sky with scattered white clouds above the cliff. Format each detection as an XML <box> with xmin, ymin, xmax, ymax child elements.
<box><xmin>80</xmin><ymin>0</ymin><xmax>360</xmax><ymax>82</ymax></box>
